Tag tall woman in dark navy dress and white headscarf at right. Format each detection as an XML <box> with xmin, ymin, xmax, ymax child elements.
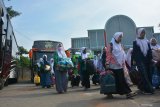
<box><xmin>131</xmin><ymin>28</ymin><xmax>153</xmax><ymax>94</ymax></box>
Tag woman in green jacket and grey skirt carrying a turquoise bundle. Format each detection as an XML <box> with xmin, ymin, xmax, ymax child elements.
<box><xmin>54</xmin><ymin>43</ymin><xmax>68</xmax><ymax>93</ymax></box>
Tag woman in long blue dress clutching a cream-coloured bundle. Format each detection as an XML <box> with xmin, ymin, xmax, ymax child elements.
<box><xmin>40</xmin><ymin>55</ymin><xmax>51</xmax><ymax>88</ymax></box>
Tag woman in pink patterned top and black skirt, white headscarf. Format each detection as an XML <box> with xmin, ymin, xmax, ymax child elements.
<box><xmin>106</xmin><ymin>32</ymin><xmax>136</xmax><ymax>98</ymax></box>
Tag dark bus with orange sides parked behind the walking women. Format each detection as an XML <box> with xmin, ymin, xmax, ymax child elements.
<box><xmin>29</xmin><ymin>40</ymin><xmax>61</xmax><ymax>82</ymax></box>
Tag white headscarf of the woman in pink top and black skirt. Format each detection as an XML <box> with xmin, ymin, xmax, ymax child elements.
<box><xmin>111</xmin><ymin>32</ymin><xmax>126</xmax><ymax>66</ymax></box>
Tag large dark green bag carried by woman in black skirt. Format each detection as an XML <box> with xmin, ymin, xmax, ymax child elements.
<box><xmin>100</xmin><ymin>73</ymin><xmax>116</xmax><ymax>94</ymax></box>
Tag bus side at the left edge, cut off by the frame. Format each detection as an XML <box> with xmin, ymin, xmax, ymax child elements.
<box><xmin>0</xmin><ymin>0</ymin><xmax>19</xmax><ymax>89</ymax></box>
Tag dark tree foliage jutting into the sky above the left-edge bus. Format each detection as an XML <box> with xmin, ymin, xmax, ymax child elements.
<box><xmin>6</xmin><ymin>0</ymin><xmax>22</xmax><ymax>19</ymax></box>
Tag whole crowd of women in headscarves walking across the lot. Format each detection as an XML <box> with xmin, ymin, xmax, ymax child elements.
<box><xmin>36</xmin><ymin>28</ymin><xmax>160</xmax><ymax>98</ymax></box>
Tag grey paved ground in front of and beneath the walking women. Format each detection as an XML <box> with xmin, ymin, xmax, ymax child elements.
<box><xmin>0</xmin><ymin>83</ymin><xmax>160</xmax><ymax>107</ymax></box>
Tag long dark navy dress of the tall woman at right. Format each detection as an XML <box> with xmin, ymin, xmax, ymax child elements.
<box><xmin>131</xmin><ymin>41</ymin><xmax>153</xmax><ymax>93</ymax></box>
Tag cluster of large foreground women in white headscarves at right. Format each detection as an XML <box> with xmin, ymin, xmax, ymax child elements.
<box><xmin>102</xmin><ymin>28</ymin><xmax>160</xmax><ymax>98</ymax></box>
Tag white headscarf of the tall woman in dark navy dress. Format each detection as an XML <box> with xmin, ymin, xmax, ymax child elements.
<box><xmin>136</xmin><ymin>28</ymin><xmax>149</xmax><ymax>56</ymax></box>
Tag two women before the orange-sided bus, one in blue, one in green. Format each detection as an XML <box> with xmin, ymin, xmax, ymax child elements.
<box><xmin>38</xmin><ymin>43</ymin><xmax>68</xmax><ymax>93</ymax></box>
